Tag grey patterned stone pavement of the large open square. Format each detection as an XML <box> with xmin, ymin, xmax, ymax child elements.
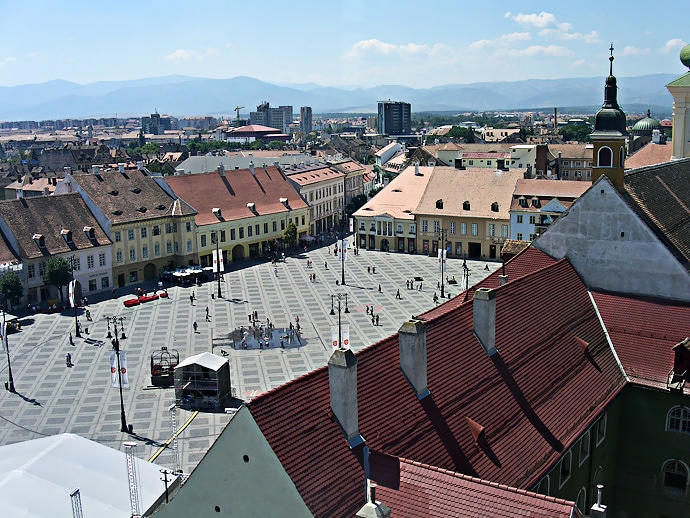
<box><xmin>0</xmin><ymin>245</ymin><xmax>500</xmax><ymax>473</ymax></box>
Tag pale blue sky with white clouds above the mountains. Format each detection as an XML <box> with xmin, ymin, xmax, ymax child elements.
<box><xmin>0</xmin><ymin>0</ymin><xmax>690</xmax><ymax>88</ymax></box>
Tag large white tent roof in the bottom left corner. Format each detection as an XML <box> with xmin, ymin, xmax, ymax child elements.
<box><xmin>0</xmin><ymin>433</ymin><xmax>176</xmax><ymax>518</ymax></box>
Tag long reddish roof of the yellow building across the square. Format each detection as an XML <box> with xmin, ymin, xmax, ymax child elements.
<box><xmin>165</xmin><ymin>166</ymin><xmax>307</xmax><ymax>225</ymax></box>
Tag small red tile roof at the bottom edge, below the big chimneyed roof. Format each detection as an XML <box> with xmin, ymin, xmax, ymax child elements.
<box><xmin>376</xmin><ymin>459</ymin><xmax>581</xmax><ymax>518</ymax></box>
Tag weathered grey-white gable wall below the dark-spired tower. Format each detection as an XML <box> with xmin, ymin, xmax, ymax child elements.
<box><xmin>533</xmin><ymin>176</ymin><xmax>690</xmax><ymax>300</ymax></box>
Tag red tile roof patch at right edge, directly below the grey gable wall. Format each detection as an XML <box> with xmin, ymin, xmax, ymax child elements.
<box><xmin>592</xmin><ymin>293</ymin><xmax>690</xmax><ymax>390</ymax></box>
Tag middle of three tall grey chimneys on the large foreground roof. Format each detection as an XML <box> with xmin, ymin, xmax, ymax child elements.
<box><xmin>398</xmin><ymin>320</ymin><xmax>430</xmax><ymax>399</ymax></box>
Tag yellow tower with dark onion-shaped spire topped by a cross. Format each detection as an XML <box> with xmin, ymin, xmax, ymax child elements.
<box><xmin>590</xmin><ymin>44</ymin><xmax>628</xmax><ymax>189</ymax></box>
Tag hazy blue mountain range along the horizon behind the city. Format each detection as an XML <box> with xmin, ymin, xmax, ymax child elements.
<box><xmin>0</xmin><ymin>74</ymin><xmax>676</xmax><ymax>121</ymax></box>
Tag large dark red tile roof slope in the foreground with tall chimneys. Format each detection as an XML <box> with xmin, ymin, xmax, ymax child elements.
<box><xmin>249</xmin><ymin>262</ymin><xmax>625</xmax><ymax>516</ymax></box>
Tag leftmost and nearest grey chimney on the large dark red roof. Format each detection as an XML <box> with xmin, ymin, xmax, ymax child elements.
<box><xmin>328</xmin><ymin>349</ymin><xmax>364</xmax><ymax>448</ymax></box>
